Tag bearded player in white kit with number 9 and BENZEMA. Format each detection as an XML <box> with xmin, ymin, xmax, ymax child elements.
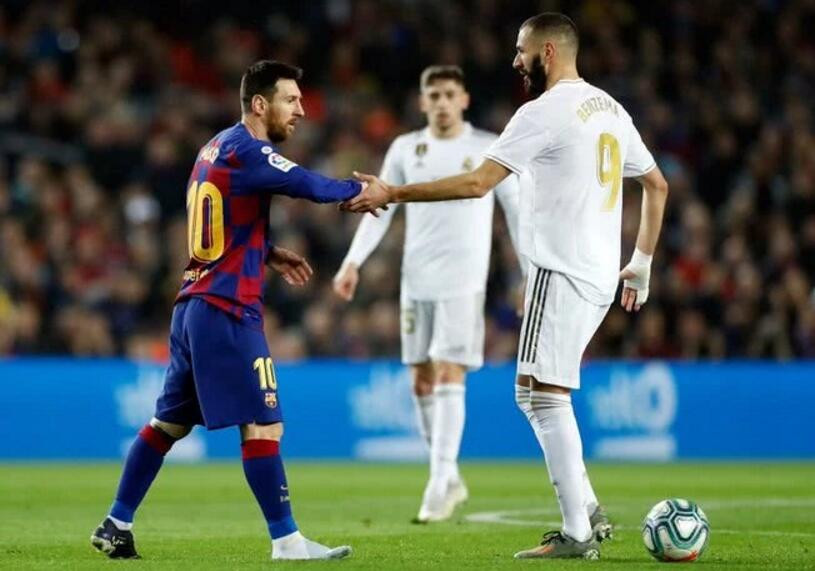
<box><xmin>343</xmin><ymin>12</ymin><xmax>668</xmax><ymax>559</ymax></box>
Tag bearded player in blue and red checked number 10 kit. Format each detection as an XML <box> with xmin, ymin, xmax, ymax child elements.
<box><xmin>91</xmin><ymin>60</ymin><xmax>364</xmax><ymax>559</ymax></box>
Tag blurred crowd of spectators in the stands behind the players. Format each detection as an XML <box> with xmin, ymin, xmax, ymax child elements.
<box><xmin>0</xmin><ymin>0</ymin><xmax>815</xmax><ymax>360</ymax></box>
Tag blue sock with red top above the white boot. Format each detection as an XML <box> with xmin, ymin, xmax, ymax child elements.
<box><xmin>241</xmin><ymin>439</ymin><xmax>297</xmax><ymax>539</ymax></box>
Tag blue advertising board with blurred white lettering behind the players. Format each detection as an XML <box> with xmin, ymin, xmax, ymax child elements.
<box><xmin>0</xmin><ymin>359</ymin><xmax>815</xmax><ymax>461</ymax></box>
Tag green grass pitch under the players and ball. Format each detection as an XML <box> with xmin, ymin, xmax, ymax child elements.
<box><xmin>0</xmin><ymin>460</ymin><xmax>815</xmax><ymax>571</ymax></box>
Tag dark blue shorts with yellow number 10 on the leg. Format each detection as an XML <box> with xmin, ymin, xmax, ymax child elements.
<box><xmin>155</xmin><ymin>297</ymin><xmax>283</xmax><ymax>430</ymax></box>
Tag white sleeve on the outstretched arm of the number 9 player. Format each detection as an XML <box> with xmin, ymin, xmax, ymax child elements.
<box><xmin>484</xmin><ymin>102</ymin><xmax>552</xmax><ymax>174</ymax></box>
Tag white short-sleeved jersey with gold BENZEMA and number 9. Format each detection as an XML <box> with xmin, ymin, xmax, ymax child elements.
<box><xmin>486</xmin><ymin>79</ymin><xmax>656</xmax><ymax>305</ymax></box>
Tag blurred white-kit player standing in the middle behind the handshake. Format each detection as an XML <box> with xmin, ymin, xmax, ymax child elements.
<box><xmin>334</xmin><ymin>65</ymin><xmax>525</xmax><ymax>523</ymax></box>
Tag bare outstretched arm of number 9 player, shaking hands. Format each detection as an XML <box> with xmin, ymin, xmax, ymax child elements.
<box><xmin>341</xmin><ymin>159</ymin><xmax>511</xmax><ymax>212</ymax></box>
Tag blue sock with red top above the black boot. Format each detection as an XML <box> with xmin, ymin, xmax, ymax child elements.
<box><xmin>110</xmin><ymin>424</ymin><xmax>175</xmax><ymax>523</ymax></box>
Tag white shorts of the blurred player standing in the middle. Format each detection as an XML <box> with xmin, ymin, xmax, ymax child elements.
<box><xmin>400</xmin><ymin>292</ymin><xmax>485</xmax><ymax>370</ymax></box>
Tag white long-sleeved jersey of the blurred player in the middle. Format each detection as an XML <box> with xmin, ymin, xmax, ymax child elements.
<box><xmin>343</xmin><ymin>123</ymin><xmax>531</xmax><ymax>301</ymax></box>
